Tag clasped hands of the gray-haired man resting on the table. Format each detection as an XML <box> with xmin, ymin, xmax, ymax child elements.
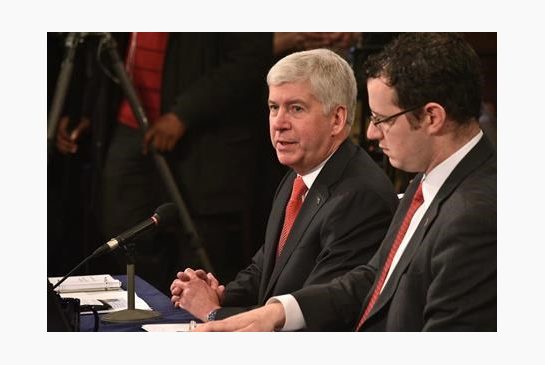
<box><xmin>170</xmin><ymin>268</ymin><xmax>225</xmax><ymax>321</ymax></box>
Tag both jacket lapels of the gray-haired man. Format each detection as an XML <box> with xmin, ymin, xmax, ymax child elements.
<box><xmin>261</xmin><ymin>140</ymin><xmax>356</xmax><ymax>298</ymax></box>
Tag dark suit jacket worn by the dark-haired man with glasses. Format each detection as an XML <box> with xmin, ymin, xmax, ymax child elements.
<box><xmin>294</xmin><ymin>138</ymin><xmax>497</xmax><ymax>331</ymax></box>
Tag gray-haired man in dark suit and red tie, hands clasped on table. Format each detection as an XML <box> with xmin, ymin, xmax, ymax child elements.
<box><xmin>171</xmin><ymin>49</ymin><xmax>397</xmax><ymax>321</ymax></box>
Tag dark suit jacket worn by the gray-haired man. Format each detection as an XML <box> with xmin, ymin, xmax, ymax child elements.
<box><xmin>217</xmin><ymin>140</ymin><xmax>398</xmax><ymax>318</ymax></box>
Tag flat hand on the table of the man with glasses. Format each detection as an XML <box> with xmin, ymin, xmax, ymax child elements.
<box><xmin>194</xmin><ymin>303</ymin><xmax>286</xmax><ymax>332</ymax></box>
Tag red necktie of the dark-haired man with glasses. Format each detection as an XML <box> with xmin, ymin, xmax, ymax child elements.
<box><xmin>356</xmin><ymin>182</ymin><xmax>424</xmax><ymax>331</ymax></box>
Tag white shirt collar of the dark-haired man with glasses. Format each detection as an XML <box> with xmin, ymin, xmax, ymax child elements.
<box><xmin>418</xmin><ymin>131</ymin><xmax>483</xmax><ymax>211</ymax></box>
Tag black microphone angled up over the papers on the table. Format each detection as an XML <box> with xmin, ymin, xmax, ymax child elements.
<box><xmin>91</xmin><ymin>203</ymin><xmax>177</xmax><ymax>258</ymax></box>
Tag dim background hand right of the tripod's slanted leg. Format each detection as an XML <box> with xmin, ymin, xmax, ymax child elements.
<box><xmin>144</xmin><ymin>113</ymin><xmax>186</xmax><ymax>154</ymax></box>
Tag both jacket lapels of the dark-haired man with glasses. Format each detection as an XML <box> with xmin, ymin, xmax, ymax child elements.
<box><xmin>369</xmin><ymin>136</ymin><xmax>493</xmax><ymax>316</ymax></box>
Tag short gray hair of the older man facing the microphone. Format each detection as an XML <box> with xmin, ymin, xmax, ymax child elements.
<box><xmin>267</xmin><ymin>48</ymin><xmax>358</xmax><ymax>125</ymax></box>
